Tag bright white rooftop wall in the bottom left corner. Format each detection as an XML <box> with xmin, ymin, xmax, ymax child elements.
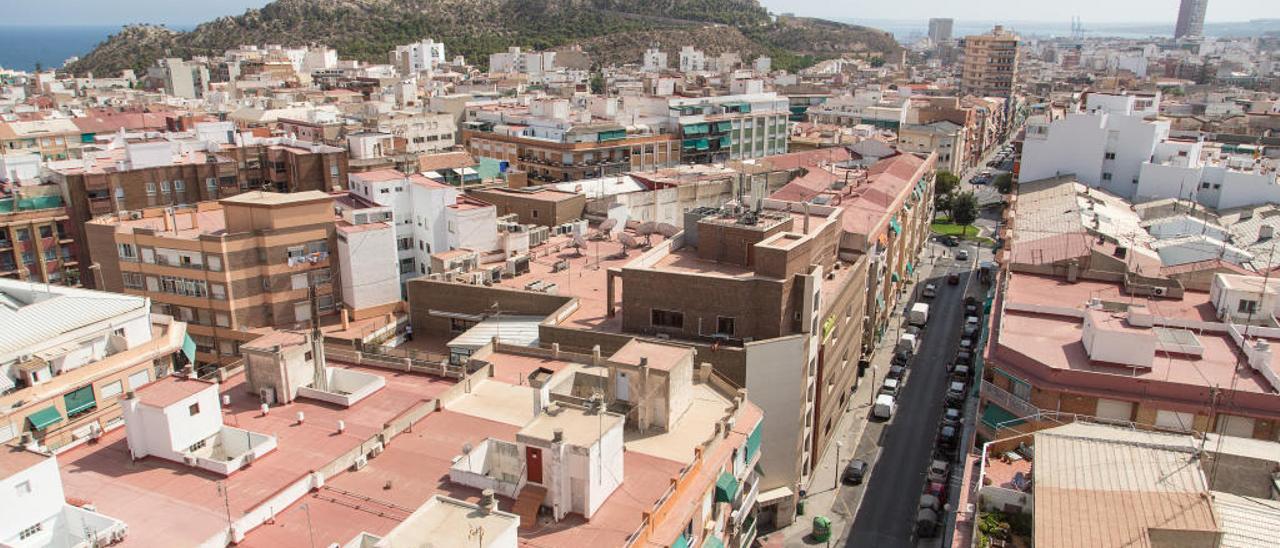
<box><xmin>0</xmin><ymin>448</ymin><xmax>64</xmax><ymax>547</ymax></box>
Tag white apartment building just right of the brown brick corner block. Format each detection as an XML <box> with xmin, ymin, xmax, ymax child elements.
<box><xmin>351</xmin><ymin>169</ymin><xmax>498</xmax><ymax>283</ymax></box>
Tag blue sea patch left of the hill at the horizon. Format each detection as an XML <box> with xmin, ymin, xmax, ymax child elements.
<box><xmin>0</xmin><ymin>26</ymin><xmax>120</xmax><ymax>70</ymax></box>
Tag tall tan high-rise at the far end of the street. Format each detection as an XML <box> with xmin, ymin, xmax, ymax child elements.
<box><xmin>960</xmin><ymin>24</ymin><xmax>1021</xmax><ymax>97</ymax></box>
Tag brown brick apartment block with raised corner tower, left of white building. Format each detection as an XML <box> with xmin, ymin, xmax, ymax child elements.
<box><xmin>84</xmin><ymin>191</ymin><xmax>339</xmax><ymax>369</ymax></box>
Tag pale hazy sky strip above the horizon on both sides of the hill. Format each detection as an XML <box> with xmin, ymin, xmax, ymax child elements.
<box><xmin>0</xmin><ymin>0</ymin><xmax>1280</xmax><ymax>26</ymax></box>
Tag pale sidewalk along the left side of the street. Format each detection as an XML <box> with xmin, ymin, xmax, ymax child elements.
<box><xmin>760</xmin><ymin>250</ymin><xmax>940</xmax><ymax>547</ymax></box>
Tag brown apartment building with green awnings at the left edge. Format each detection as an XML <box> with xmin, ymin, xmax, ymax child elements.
<box><xmin>0</xmin><ymin>184</ymin><xmax>81</xmax><ymax>286</ymax></box>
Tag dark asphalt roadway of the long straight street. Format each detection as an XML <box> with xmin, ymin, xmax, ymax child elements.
<box><xmin>841</xmin><ymin>247</ymin><xmax>975</xmax><ymax>548</ymax></box>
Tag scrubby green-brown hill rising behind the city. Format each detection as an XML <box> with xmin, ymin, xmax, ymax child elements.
<box><xmin>65</xmin><ymin>0</ymin><xmax>899</xmax><ymax>74</ymax></box>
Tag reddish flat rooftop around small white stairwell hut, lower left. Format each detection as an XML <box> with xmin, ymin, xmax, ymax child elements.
<box><xmin>59</xmin><ymin>362</ymin><xmax>461</xmax><ymax>545</ymax></box>
